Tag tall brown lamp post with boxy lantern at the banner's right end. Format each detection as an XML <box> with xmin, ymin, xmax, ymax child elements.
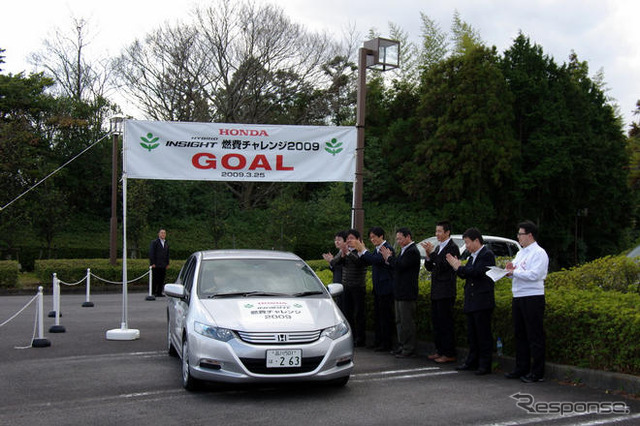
<box><xmin>351</xmin><ymin>38</ymin><xmax>400</xmax><ymax>235</ymax></box>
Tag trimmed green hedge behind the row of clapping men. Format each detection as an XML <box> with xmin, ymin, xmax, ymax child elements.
<box><xmin>316</xmin><ymin>259</ymin><xmax>640</xmax><ymax>375</ymax></box>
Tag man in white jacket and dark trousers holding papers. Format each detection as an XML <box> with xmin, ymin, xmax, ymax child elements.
<box><xmin>505</xmin><ymin>221</ymin><xmax>549</xmax><ymax>383</ymax></box>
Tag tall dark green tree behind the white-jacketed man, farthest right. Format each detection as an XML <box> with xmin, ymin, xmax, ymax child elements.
<box><xmin>502</xmin><ymin>34</ymin><xmax>630</xmax><ymax>266</ymax></box>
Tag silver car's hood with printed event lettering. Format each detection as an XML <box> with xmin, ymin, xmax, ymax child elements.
<box><xmin>201</xmin><ymin>297</ymin><xmax>343</xmax><ymax>332</ymax></box>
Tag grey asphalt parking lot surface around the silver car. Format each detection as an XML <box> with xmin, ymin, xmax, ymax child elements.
<box><xmin>0</xmin><ymin>293</ymin><xmax>640</xmax><ymax>425</ymax></box>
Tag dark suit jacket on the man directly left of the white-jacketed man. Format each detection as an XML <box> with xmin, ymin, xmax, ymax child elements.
<box><xmin>457</xmin><ymin>246</ymin><xmax>496</xmax><ymax>312</ymax></box>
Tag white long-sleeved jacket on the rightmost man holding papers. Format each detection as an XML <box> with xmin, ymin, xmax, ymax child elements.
<box><xmin>511</xmin><ymin>241</ymin><xmax>549</xmax><ymax>297</ymax></box>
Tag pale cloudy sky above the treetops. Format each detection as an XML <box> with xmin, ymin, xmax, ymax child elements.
<box><xmin>0</xmin><ymin>0</ymin><xmax>640</xmax><ymax>131</ymax></box>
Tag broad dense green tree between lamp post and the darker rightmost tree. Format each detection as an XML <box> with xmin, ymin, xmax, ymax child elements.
<box><xmin>402</xmin><ymin>47</ymin><xmax>519</xmax><ymax>229</ymax></box>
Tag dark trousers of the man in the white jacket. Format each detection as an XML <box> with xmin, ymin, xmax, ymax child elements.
<box><xmin>511</xmin><ymin>295</ymin><xmax>545</xmax><ymax>377</ymax></box>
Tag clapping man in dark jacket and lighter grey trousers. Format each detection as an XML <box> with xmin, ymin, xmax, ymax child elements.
<box><xmin>380</xmin><ymin>228</ymin><xmax>421</xmax><ymax>358</ymax></box>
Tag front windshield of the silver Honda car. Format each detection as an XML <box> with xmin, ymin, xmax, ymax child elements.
<box><xmin>198</xmin><ymin>259</ymin><xmax>325</xmax><ymax>298</ymax></box>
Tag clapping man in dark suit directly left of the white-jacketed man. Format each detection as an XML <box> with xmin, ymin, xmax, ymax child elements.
<box><xmin>447</xmin><ymin>228</ymin><xmax>496</xmax><ymax>376</ymax></box>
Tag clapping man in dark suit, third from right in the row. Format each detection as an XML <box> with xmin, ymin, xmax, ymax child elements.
<box><xmin>422</xmin><ymin>221</ymin><xmax>460</xmax><ymax>363</ymax></box>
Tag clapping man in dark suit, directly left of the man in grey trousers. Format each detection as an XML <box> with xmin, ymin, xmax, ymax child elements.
<box><xmin>356</xmin><ymin>226</ymin><xmax>394</xmax><ymax>352</ymax></box>
